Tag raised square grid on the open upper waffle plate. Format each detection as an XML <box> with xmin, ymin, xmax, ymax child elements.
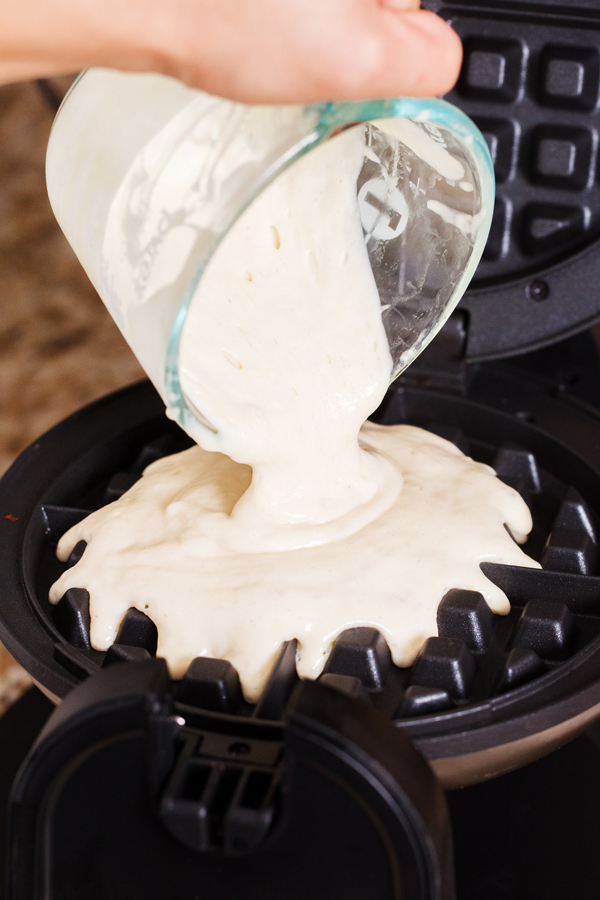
<box><xmin>426</xmin><ymin>0</ymin><xmax>600</xmax><ymax>287</ymax></box>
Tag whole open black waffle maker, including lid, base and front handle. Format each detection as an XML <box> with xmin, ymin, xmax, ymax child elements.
<box><xmin>5</xmin><ymin>0</ymin><xmax>600</xmax><ymax>900</ymax></box>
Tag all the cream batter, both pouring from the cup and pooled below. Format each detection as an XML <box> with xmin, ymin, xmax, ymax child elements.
<box><xmin>50</xmin><ymin>123</ymin><xmax>537</xmax><ymax>700</ymax></box>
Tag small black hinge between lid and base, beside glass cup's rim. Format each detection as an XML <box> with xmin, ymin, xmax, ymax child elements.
<box><xmin>398</xmin><ymin>309</ymin><xmax>471</xmax><ymax>397</ymax></box>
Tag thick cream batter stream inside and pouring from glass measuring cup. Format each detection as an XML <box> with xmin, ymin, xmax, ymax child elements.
<box><xmin>180</xmin><ymin>128</ymin><xmax>402</xmax><ymax>553</ymax></box>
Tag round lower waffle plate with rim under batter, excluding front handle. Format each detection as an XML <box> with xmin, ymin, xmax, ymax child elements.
<box><xmin>0</xmin><ymin>326</ymin><xmax>600</xmax><ymax>788</ymax></box>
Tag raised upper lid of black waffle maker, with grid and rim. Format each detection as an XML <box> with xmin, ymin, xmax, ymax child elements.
<box><xmin>423</xmin><ymin>0</ymin><xmax>600</xmax><ymax>360</ymax></box>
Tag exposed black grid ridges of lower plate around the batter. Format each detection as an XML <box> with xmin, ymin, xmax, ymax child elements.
<box><xmin>43</xmin><ymin>422</ymin><xmax>600</xmax><ymax>720</ymax></box>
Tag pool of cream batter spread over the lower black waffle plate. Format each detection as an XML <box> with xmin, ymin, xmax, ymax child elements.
<box><xmin>51</xmin><ymin>423</ymin><xmax>537</xmax><ymax>701</ymax></box>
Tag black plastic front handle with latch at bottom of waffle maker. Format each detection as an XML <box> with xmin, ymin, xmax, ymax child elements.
<box><xmin>9</xmin><ymin>659</ymin><xmax>453</xmax><ymax>900</ymax></box>
